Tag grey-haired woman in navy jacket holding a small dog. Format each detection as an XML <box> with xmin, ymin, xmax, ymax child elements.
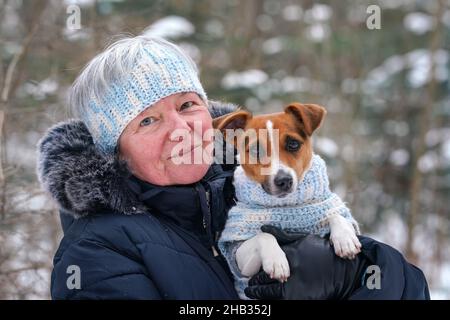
<box><xmin>38</xmin><ymin>36</ymin><xmax>428</xmax><ymax>299</ymax></box>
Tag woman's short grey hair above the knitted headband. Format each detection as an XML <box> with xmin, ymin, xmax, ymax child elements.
<box><xmin>69</xmin><ymin>35</ymin><xmax>198</xmax><ymax>117</ymax></box>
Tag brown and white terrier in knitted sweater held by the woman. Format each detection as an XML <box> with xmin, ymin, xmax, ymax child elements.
<box><xmin>213</xmin><ymin>103</ymin><xmax>361</xmax><ymax>299</ymax></box>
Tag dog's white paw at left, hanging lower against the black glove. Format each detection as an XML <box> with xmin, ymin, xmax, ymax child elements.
<box><xmin>261</xmin><ymin>246</ymin><xmax>290</xmax><ymax>282</ymax></box>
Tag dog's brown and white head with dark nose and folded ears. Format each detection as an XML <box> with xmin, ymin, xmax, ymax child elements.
<box><xmin>213</xmin><ymin>102</ymin><xmax>326</xmax><ymax>197</ymax></box>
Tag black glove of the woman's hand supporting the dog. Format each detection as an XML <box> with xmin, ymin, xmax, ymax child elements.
<box><xmin>245</xmin><ymin>226</ymin><xmax>365</xmax><ymax>300</ymax></box>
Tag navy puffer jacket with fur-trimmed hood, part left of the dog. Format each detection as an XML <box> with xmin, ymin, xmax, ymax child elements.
<box><xmin>38</xmin><ymin>103</ymin><xmax>241</xmax><ymax>299</ymax></box>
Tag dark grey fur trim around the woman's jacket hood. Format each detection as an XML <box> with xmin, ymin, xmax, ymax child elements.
<box><xmin>37</xmin><ymin>101</ymin><xmax>237</xmax><ymax>218</ymax></box>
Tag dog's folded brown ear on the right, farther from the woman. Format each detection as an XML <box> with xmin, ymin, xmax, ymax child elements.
<box><xmin>284</xmin><ymin>102</ymin><xmax>327</xmax><ymax>136</ymax></box>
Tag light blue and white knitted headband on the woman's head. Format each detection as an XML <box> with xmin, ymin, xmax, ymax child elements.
<box><xmin>80</xmin><ymin>40</ymin><xmax>207</xmax><ymax>154</ymax></box>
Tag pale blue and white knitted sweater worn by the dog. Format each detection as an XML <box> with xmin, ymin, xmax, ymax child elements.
<box><xmin>218</xmin><ymin>154</ymin><xmax>360</xmax><ymax>299</ymax></box>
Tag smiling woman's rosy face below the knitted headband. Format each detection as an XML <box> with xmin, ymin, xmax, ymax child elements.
<box><xmin>119</xmin><ymin>92</ymin><xmax>213</xmax><ymax>186</ymax></box>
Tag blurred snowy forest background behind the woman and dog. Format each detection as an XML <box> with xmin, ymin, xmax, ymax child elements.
<box><xmin>0</xmin><ymin>0</ymin><xmax>450</xmax><ymax>299</ymax></box>
